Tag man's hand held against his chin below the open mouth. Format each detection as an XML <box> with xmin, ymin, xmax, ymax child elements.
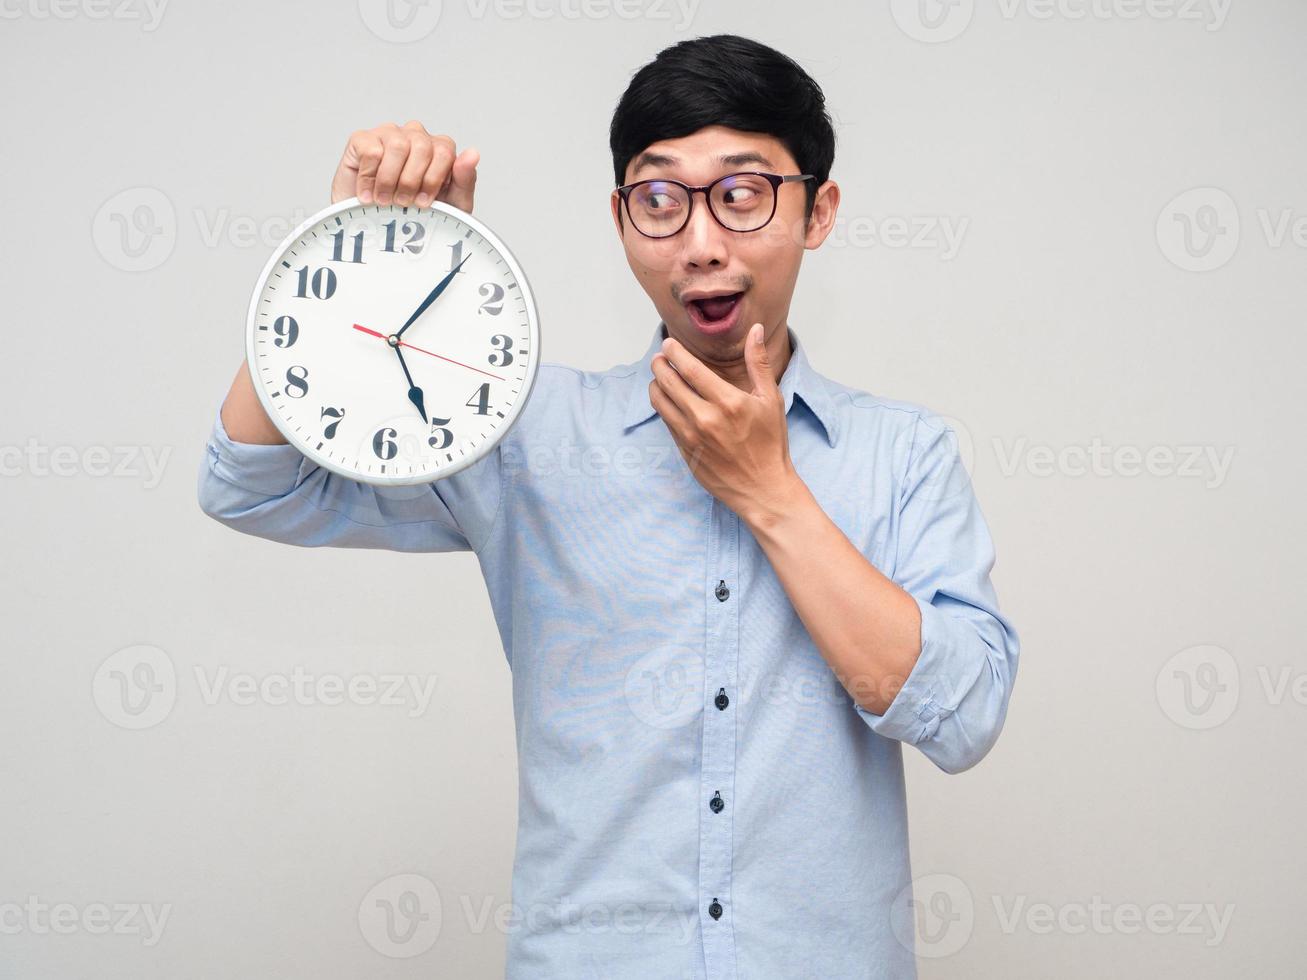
<box><xmin>650</xmin><ymin>324</ymin><xmax>802</xmax><ymax>523</ymax></box>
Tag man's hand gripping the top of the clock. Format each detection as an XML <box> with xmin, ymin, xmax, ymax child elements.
<box><xmin>331</xmin><ymin>120</ymin><xmax>481</xmax><ymax>213</ymax></box>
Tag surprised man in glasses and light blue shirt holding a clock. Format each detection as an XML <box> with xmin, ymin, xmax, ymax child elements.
<box><xmin>199</xmin><ymin>35</ymin><xmax>1018</xmax><ymax>980</ymax></box>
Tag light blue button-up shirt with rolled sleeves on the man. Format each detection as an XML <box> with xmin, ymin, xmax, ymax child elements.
<box><xmin>199</xmin><ymin>323</ymin><xmax>1018</xmax><ymax>980</ymax></box>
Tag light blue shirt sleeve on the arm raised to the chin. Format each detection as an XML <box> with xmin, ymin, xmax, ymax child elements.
<box><xmin>855</xmin><ymin>416</ymin><xmax>1019</xmax><ymax>774</ymax></box>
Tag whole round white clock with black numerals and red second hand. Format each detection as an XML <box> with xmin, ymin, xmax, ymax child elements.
<box><xmin>246</xmin><ymin>199</ymin><xmax>540</xmax><ymax>485</ymax></box>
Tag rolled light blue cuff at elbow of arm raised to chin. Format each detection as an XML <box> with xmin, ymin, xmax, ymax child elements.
<box><xmin>853</xmin><ymin>596</ymin><xmax>985</xmax><ymax>745</ymax></box>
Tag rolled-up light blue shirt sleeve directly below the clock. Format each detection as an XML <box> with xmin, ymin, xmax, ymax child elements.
<box><xmin>197</xmin><ymin>410</ymin><xmax>503</xmax><ymax>551</ymax></box>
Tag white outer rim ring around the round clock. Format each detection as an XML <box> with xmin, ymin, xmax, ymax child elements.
<box><xmin>244</xmin><ymin>197</ymin><xmax>541</xmax><ymax>487</ymax></box>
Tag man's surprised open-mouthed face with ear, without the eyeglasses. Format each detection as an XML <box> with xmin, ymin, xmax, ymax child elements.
<box><xmin>612</xmin><ymin>125</ymin><xmax>838</xmax><ymax>363</ymax></box>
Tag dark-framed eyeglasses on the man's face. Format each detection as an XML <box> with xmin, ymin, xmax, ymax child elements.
<box><xmin>617</xmin><ymin>171</ymin><xmax>816</xmax><ymax>238</ymax></box>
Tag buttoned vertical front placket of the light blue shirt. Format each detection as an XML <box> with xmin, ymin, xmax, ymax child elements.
<box><xmin>699</xmin><ymin>498</ymin><xmax>740</xmax><ymax>980</ymax></box>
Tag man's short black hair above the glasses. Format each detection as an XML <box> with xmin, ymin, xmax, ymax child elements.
<box><xmin>608</xmin><ymin>34</ymin><xmax>835</xmax><ymax>217</ymax></box>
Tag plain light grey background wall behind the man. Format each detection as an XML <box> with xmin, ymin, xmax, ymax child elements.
<box><xmin>0</xmin><ymin>0</ymin><xmax>1307</xmax><ymax>979</ymax></box>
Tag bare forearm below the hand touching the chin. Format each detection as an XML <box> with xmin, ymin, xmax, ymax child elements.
<box><xmin>740</xmin><ymin>474</ymin><xmax>921</xmax><ymax>713</ymax></box>
